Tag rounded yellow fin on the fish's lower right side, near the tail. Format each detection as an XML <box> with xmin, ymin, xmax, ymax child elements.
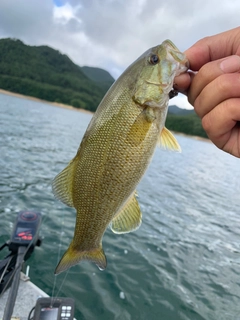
<box><xmin>111</xmin><ymin>192</ymin><xmax>142</xmax><ymax>234</ymax></box>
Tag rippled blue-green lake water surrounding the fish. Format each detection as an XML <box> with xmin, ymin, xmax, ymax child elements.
<box><xmin>0</xmin><ymin>94</ymin><xmax>240</xmax><ymax>320</ymax></box>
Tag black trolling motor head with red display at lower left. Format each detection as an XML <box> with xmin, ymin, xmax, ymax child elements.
<box><xmin>9</xmin><ymin>211</ymin><xmax>42</xmax><ymax>252</ymax></box>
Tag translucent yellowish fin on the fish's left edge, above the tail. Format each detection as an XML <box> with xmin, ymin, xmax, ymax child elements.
<box><xmin>52</xmin><ymin>158</ymin><xmax>76</xmax><ymax>207</ymax></box>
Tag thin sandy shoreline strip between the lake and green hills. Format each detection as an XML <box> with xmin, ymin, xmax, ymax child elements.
<box><xmin>0</xmin><ymin>89</ymin><xmax>210</xmax><ymax>142</ymax></box>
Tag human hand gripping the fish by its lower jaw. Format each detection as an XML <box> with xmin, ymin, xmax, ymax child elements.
<box><xmin>175</xmin><ymin>28</ymin><xmax>240</xmax><ymax>158</ymax></box>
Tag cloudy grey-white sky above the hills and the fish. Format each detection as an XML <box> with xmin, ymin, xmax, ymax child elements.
<box><xmin>0</xmin><ymin>0</ymin><xmax>240</xmax><ymax>107</ymax></box>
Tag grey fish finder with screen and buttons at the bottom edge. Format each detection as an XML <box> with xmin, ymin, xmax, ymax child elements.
<box><xmin>33</xmin><ymin>297</ymin><xmax>74</xmax><ymax>320</ymax></box>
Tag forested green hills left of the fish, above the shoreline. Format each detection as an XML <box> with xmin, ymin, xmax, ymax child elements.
<box><xmin>0</xmin><ymin>39</ymin><xmax>114</xmax><ymax>111</ymax></box>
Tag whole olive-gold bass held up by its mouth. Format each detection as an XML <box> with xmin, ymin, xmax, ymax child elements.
<box><xmin>52</xmin><ymin>40</ymin><xmax>189</xmax><ymax>274</ymax></box>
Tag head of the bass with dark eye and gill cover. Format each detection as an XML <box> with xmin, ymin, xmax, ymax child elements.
<box><xmin>133</xmin><ymin>40</ymin><xmax>189</xmax><ymax>108</ymax></box>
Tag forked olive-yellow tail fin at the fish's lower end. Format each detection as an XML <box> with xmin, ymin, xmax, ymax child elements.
<box><xmin>54</xmin><ymin>244</ymin><xmax>107</xmax><ymax>274</ymax></box>
